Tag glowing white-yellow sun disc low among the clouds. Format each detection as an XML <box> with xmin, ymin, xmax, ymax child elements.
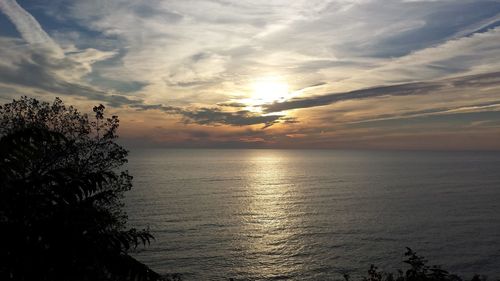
<box><xmin>249</xmin><ymin>76</ymin><xmax>289</xmax><ymax>105</ymax></box>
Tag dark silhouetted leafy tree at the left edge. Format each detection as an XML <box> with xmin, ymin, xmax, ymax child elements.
<box><xmin>0</xmin><ymin>97</ymin><xmax>161</xmax><ymax>281</ymax></box>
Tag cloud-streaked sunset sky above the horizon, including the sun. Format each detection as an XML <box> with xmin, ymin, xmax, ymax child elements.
<box><xmin>0</xmin><ymin>0</ymin><xmax>500</xmax><ymax>150</ymax></box>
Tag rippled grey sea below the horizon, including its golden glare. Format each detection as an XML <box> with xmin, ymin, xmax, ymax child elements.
<box><xmin>125</xmin><ymin>149</ymin><xmax>500</xmax><ymax>280</ymax></box>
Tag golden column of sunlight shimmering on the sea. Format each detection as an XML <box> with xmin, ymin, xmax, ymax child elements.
<box><xmin>236</xmin><ymin>151</ymin><xmax>302</xmax><ymax>278</ymax></box>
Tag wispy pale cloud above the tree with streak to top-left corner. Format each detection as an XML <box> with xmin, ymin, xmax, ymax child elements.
<box><xmin>0</xmin><ymin>0</ymin><xmax>146</xmax><ymax>106</ymax></box>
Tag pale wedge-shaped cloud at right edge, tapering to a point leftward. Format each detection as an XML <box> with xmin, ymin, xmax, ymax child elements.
<box><xmin>352</xmin><ymin>28</ymin><xmax>500</xmax><ymax>84</ymax></box>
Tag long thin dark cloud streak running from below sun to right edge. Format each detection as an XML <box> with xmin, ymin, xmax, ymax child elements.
<box><xmin>263</xmin><ymin>72</ymin><xmax>500</xmax><ymax>113</ymax></box>
